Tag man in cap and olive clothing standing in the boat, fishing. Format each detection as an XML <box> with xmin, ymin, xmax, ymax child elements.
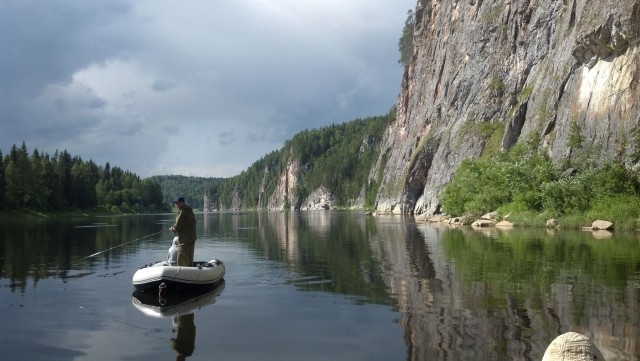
<box><xmin>169</xmin><ymin>196</ymin><xmax>198</xmax><ymax>267</ymax></box>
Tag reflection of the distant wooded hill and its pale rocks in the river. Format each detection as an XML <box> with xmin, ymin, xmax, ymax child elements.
<box><xmin>259</xmin><ymin>211</ymin><xmax>391</xmax><ymax>298</ymax></box>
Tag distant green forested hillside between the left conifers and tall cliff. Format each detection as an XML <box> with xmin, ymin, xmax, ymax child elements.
<box><xmin>155</xmin><ymin>108</ymin><xmax>395</xmax><ymax>210</ymax></box>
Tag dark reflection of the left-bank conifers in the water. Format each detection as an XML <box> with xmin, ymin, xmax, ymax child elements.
<box><xmin>0</xmin><ymin>216</ymin><xmax>166</xmax><ymax>292</ymax></box>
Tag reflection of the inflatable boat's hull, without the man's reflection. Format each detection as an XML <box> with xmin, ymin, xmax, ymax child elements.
<box><xmin>131</xmin><ymin>281</ymin><xmax>224</xmax><ymax>318</ymax></box>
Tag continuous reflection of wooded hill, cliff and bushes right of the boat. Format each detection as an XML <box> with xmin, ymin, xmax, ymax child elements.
<box><xmin>202</xmin><ymin>211</ymin><xmax>640</xmax><ymax>360</ymax></box>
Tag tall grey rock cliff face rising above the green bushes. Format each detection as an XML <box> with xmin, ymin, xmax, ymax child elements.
<box><xmin>371</xmin><ymin>0</ymin><xmax>640</xmax><ymax>214</ymax></box>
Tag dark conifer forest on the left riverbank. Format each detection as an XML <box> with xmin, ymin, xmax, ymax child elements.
<box><xmin>0</xmin><ymin>142</ymin><xmax>169</xmax><ymax>213</ymax></box>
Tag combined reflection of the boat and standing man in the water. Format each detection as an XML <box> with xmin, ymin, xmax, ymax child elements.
<box><xmin>132</xmin><ymin>282</ymin><xmax>224</xmax><ymax>360</ymax></box>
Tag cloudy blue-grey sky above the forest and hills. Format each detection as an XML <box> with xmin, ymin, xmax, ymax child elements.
<box><xmin>0</xmin><ymin>0</ymin><xmax>416</xmax><ymax>178</ymax></box>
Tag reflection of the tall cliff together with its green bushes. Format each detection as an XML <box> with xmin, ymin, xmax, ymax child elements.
<box><xmin>404</xmin><ymin>225</ymin><xmax>640</xmax><ymax>360</ymax></box>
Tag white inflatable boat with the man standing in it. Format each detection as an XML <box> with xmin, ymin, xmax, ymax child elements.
<box><xmin>133</xmin><ymin>259</ymin><xmax>225</xmax><ymax>290</ymax></box>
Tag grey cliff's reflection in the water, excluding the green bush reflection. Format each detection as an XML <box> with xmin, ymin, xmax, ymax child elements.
<box><xmin>379</xmin><ymin>224</ymin><xmax>640</xmax><ymax>360</ymax></box>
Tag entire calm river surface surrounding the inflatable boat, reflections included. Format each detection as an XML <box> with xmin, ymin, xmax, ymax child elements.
<box><xmin>0</xmin><ymin>211</ymin><xmax>640</xmax><ymax>361</ymax></box>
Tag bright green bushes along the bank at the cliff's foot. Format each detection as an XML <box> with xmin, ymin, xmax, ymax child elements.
<box><xmin>442</xmin><ymin>141</ymin><xmax>640</xmax><ymax>226</ymax></box>
